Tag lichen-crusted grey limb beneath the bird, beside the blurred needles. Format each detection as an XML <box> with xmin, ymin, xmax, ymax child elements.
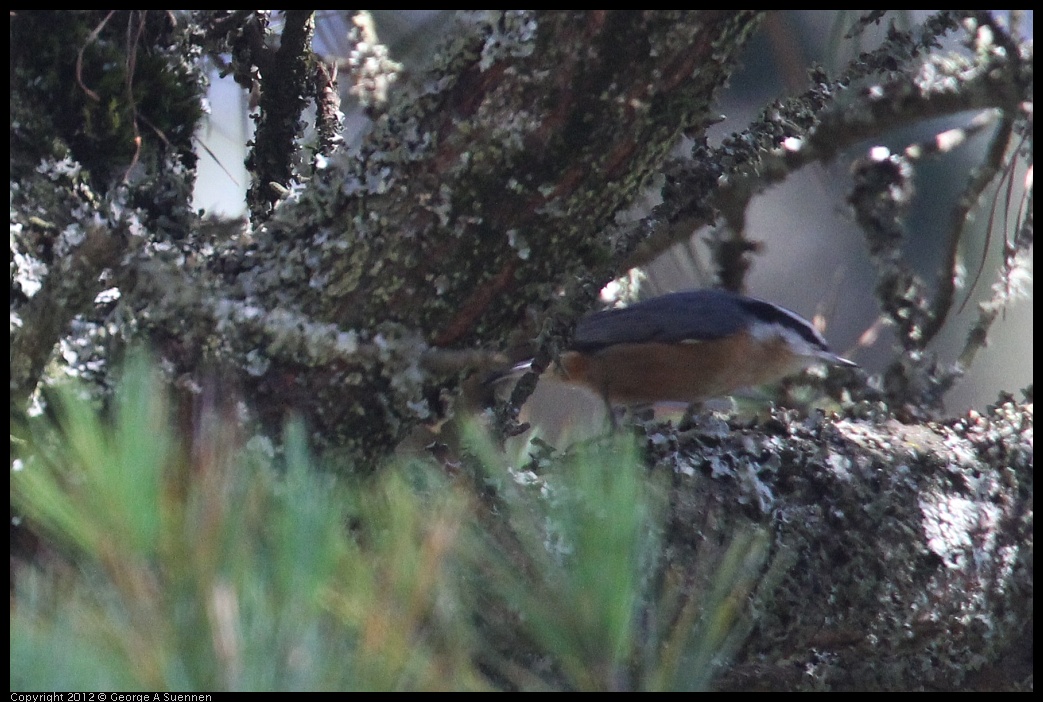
<box><xmin>648</xmin><ymin>398</ymin><xmax>1033</xmax><ymax>689</ymax></box>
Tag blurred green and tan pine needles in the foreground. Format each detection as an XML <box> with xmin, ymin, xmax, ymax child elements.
<box><xmin>10</xmin><ymin>358</ymin><xmax>770</xmax><ymax>691</ymax></box>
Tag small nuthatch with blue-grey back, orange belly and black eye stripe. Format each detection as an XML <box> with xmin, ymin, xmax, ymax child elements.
<box><xmin>529</xmin><ymin>290</ymin><xmax>857</xmax><ymax>405</ymax></box>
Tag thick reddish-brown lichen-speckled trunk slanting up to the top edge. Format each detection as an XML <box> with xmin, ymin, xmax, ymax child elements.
<box><xmin>211</xmin><ymin>11</ymin><xmax>757</xmax><ymax>454</ymax></box>
